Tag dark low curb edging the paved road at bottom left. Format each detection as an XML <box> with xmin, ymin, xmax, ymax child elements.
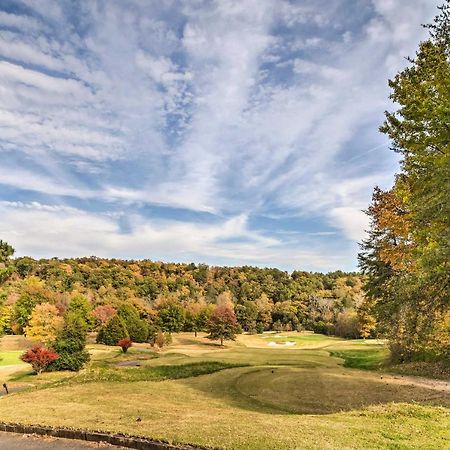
<box><xmin>0</xmin><ymin>423</ymin><xmax>206</xmax><ymax>450</ymax></box>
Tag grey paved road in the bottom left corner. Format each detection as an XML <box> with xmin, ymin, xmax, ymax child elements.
<box><xmin>0</xmin><ymin>431</ymin><xmax>125</xmax><ymax>450</ymax></box>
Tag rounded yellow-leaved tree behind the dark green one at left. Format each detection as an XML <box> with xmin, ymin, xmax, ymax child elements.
<box><xmin>24</xmin><ymin>303</ymin><xmax>64</xmax><ymax>344</ymax></box>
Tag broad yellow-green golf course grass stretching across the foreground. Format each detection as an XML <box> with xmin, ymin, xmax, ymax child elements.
<box><xmin>0</xmin><ymin>333</ymin><xmax>450</xmax><ymax>449</ymax></box>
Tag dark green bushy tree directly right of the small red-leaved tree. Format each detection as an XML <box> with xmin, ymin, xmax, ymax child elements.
<box><xmin>49</xmin><ymin>312</ymin><xmax>90</xmax><ymax>371</ymax></box>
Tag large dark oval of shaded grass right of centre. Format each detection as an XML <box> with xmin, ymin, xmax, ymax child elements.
<box><xmin>178</xmin><ymin>367</ymin><xmax>450</xmax><ymax>415</ymax></box>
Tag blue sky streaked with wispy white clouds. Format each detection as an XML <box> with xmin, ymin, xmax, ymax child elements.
<box><xmin>0</xmin><ymin>0</ymin><xmax>437</xmax><ymax>271</ymax></box>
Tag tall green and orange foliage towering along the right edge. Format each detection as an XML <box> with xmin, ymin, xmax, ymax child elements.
<box><xmin>359</xmin><ymin>1</ymin><xmax>450</xmax><ymax>361</ymax></box>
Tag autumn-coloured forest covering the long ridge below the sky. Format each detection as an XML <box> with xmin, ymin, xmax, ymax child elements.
<box><xmin>0</xmin><ymin>251</ymin><xmax>375</xmax><ymax>341</ymax></box>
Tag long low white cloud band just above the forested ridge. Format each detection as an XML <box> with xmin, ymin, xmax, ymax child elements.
<box><xmin>0</xmin><ymin>202</ymin><xmax>344</xmax><ymax>270</ymax></box>
